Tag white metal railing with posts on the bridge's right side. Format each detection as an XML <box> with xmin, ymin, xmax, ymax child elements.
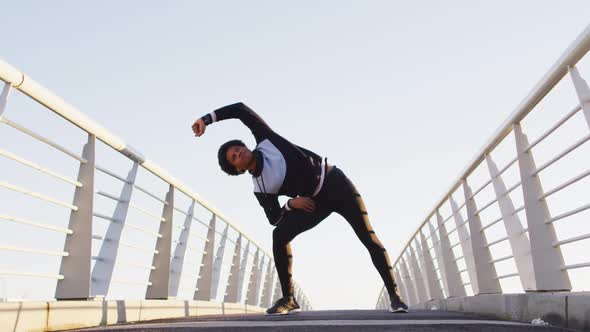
<box><xmin>377</xmin><ymin>26</ymin><xmax>590</xmax><ymax>308</ymax></box>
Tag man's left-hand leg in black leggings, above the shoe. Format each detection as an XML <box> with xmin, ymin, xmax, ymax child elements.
<box><xmin>272</xmin><ymin>208</ymin><xmax>331</xmax><ymax>297</ymax></box>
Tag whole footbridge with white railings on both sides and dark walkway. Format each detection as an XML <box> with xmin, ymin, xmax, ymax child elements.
<box><xmin>0</xmin><ymin>26</ymin><xmax>590</xmax><ymax>331</ymax></box>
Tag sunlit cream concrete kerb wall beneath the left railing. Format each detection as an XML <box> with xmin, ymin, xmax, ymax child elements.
<box><xmin>0</xmin><ymin>300</ymin><xmax>264</xmax><ymax>332</ymax></box>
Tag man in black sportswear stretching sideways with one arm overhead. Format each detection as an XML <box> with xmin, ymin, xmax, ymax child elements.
<box><xmin>192</xmin><ymin>103</ymin><xmax>408</xmax><ymax>314</ymax></box>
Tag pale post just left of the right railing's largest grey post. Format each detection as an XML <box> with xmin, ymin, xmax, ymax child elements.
<box><xmin>486</xmin><ymin>155</ymin><xmax>536</xmax><ymax>291</ymax></box>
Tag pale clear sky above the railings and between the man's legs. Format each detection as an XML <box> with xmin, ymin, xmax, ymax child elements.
<box><xmin>0</xmin><ymin>0</ymin><xmax>590</xmax><ymax>309</ymax></box>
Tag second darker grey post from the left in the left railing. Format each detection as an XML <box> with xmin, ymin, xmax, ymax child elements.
<box><xmin>145</xmin><ymin>185</ymin><xmax>174</xmax><ymax>299</ymax></box>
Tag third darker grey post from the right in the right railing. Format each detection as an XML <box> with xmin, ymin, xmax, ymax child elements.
<box><xmin>431</xmin><ymin>210</ymin><xmax>466</xmax><ymax>297</ymax></box>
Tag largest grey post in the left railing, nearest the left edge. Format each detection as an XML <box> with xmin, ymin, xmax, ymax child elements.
<box><xmin>55</xmin><ymin>134</ymin><xmax>96</xmax><ymax>300</ymax></box>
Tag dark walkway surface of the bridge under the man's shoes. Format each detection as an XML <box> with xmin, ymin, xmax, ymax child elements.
<box><xmin>68</xmin><ymin>310</ymin><xmax>571</xmax><ymax>332</ymax></box>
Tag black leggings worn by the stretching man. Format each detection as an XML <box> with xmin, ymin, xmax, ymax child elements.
<box><xmin>272</xmin><ymin>167</ymin><xmax>396</xmax><ymax>297</ymax></box>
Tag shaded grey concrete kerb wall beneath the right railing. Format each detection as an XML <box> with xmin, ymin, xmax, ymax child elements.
<box><xmin>412</xmin><ymin>292</ymin><xmax>590</xmax><ymax>331</ymax></box>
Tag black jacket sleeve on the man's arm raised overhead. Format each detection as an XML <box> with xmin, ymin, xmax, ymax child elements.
<box><xmin>201</xmin><ymin>103</ymin><xmax>272</xmax><ymax>143</ymax></box>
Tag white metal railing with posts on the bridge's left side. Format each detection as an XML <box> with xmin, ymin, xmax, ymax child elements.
<box><xmin>0</xmin><ymin>60</ymin><xmax>311</xmax><ymax>309</ymax></box>
